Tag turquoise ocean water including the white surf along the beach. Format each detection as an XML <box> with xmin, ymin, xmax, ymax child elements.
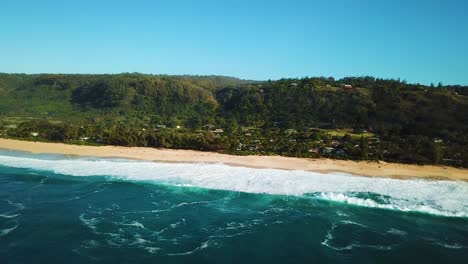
<box><xmin>0</xmin><ymin>151</ymin><xmax>468</xmax><ymax>263</ymax></box>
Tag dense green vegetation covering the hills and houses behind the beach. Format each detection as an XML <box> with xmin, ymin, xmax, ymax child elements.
<box><xmin>0</xmin><ymin>74</ymin><xmax>468</xmax><ymax>167</ymax></box>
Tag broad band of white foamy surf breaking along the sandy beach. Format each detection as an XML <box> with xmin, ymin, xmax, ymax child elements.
<box><xmin>0</xmin><ymin>155</ymin><xmax>468</xmax><ymax>217</ymax></box>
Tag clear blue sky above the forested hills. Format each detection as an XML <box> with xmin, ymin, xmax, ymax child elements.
<box><xmin>0</xmin><ymin>0</ymin><xmax>468</xmax><ymax>85</ymax></box>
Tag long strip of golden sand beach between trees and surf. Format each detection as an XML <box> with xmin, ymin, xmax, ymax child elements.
<box><xmin>0</xmin><ymin>138</ymin><xmax>468</xmax><ymax>181</ymax></box>
